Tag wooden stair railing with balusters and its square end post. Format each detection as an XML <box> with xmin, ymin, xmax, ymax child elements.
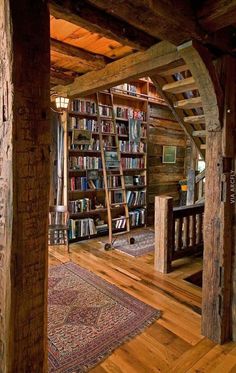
<box><xmin>154</xmin><ymin>196</ymin><xmax>204</xmax><ymax>273</ymax></box>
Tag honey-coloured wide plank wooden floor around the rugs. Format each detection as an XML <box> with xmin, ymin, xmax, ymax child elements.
<box><xmin>49</xmin><ymin>228</ymin><xmax>236</xmax><ymax>373</ymax></box>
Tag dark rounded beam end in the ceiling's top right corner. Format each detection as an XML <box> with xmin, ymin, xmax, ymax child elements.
<box><xmin>197</xmin><ymin>0</ymin><xmax>236</xmax><ymax>32</ymax></box>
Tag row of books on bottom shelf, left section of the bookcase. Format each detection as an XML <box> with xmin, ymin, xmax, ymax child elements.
<box><xmin>69</xmin><ymin>218</ymin><xmax>97</xmax><ymax>240</ymax></box>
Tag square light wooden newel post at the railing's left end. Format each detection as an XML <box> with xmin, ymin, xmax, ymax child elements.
<box><xmin>154</xmin><ymin>196</ymin><xmax>174</xmax><ymax>273</ymax></box>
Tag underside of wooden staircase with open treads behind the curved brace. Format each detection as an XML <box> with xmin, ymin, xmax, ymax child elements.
<box><xmin>150</xmin><ymin>59</ymin><xmax>206</xmax><ymax>159</ymax></box>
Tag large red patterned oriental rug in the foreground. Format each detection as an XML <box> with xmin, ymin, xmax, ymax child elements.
<box><xmin>48</xmin><ymin>262</ymin><xmax>160</xmax><ymax>373</ymax></box>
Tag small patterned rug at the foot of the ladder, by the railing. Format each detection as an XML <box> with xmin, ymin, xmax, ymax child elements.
<box><xmin>113</xmin><ymin>231</ymin><xmax>155</xmax><ymax>256</ymax></box>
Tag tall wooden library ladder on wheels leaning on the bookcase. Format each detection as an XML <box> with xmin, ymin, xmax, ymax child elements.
<box><xmin>96</xmin><ymin>90</ymin><xmax>134</xmax><ymax>250</ymax></box>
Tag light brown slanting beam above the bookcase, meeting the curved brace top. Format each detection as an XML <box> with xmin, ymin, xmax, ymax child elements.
<box><xmin>52</xmin><ymin>41</ymin><xmax>178</xmax><ymax>97</ymax></box>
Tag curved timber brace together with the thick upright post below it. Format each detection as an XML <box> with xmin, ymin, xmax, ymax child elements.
<box><xmin>178</xmin><ymin>42</ymin><xmax>235</xmax><ymax>343</ymax></box>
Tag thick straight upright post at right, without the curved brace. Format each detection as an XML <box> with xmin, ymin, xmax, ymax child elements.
<box><xmin>202</xmin><ymin>57</ymin><xmax>236</xmax><ymax>343</ymax></box>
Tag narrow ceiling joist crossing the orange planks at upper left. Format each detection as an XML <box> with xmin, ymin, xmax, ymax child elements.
<box><xmin>50</xmin><ymin>38</ymin><xmax>111</xmax><ymax>69</ymax></box>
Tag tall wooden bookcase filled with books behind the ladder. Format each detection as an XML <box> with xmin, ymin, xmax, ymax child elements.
<box><xmin>67</xmin><ymin>79</ymin><xmax>166</xmax><ymax>242</ymax></box>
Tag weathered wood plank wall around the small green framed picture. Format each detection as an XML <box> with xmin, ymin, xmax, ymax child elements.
<box><xmin>147</xmin><ymin>106</ymin><xmax>186</xmax><ymax>224</ymax></box>
